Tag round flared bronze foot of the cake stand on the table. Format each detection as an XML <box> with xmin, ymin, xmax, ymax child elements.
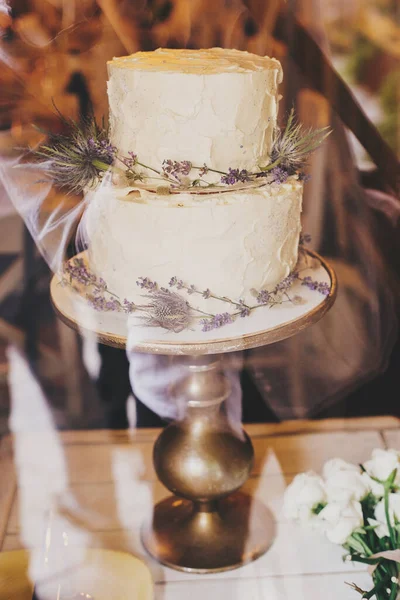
<box><xmin>142</xmin><ymin>492</ymin><xmax>275</xmax><ymax>573</ymax></box>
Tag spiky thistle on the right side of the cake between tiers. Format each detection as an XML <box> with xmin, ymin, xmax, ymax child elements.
<box><xmin>261</xmin><ymin>108</ymin><xmax>331</xmax><ymax>175</ymax></box>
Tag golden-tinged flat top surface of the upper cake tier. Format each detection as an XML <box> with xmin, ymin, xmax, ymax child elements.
<box><xmin>107</xmin><ymin>48</ymin><xmax>281</xmax><ymax>75</ymax></box>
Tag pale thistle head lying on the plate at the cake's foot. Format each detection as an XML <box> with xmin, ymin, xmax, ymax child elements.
<box><xmin>140</xmin><ymin>290</ymin><xmax>192</xmax><ymax>333</ymax></box>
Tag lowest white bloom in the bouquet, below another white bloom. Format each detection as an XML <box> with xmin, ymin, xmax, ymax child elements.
<box><xmin>318</xmin><ymin>500</ymin><xmax>364</xmax><ymax>545</ymax></box>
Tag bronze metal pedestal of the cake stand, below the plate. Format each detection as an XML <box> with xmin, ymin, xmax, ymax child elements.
<box><xmin>142</xmin><ymin>355</ymin><xmax>275</xmax><ymax>573</ymax></box>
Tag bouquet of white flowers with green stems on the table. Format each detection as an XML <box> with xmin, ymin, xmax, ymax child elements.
<box><xmin>284</xmin><ymin>449</ymin><xmax>400</xmax><ymax>600</ymax></box>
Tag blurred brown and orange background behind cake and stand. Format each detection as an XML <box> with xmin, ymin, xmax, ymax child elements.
<box><xmin>0</xmin><ymin>0</ymin><xmax>400</xmax><ymax>435</ymax></box>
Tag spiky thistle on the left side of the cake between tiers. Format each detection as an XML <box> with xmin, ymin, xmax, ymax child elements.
<box><xmin>35</xmin><ymin>115</ymin><xmax>116</xmax><ymax>193</ymax></box>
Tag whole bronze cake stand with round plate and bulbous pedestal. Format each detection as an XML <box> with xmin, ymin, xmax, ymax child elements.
<box><xmin>51</xmin><ymin>251</ymin><xmax>337</xmax><ymax>573</ymax></box>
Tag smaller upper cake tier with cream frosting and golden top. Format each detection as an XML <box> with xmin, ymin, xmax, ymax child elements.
<box><xmin>108</xmin><ymin>48</ymin><xmax>282</xmax><ymax>180</ymax></box>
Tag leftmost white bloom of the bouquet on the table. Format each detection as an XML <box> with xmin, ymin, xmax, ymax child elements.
<box><xmin>283</xmin><ymin>472</ymin><xmax>326</xmax><ymax>522</ymax></box>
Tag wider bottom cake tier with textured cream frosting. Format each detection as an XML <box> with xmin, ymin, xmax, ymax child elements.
<box><xmin>83</xmin><ymin>177</ymin><xmax>303</xmax><ymax>312</ymax></box>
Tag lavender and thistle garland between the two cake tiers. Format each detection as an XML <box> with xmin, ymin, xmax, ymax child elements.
<box><xmin>35</xmin><ymin>109</ymin><xmax>331</xmax><ymax>193</ymax></box>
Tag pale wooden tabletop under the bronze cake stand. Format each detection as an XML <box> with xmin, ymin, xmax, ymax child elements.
<box><xmin>0</xmin><ymin>417</ymin><xmax>400</xmax><ymax>600</ymax></box>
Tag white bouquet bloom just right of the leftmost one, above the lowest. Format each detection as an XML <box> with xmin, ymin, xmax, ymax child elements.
<box><xmin>323</xmin><ymin>458</ymin><xmax>371</xmax><ymax>504</ymax></box>
